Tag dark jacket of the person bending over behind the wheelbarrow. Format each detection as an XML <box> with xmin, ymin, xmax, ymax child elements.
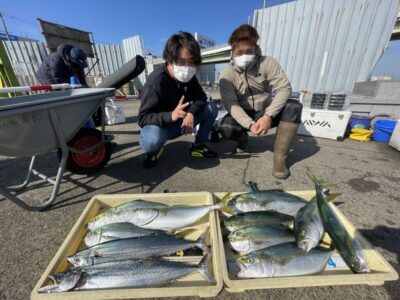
<box><xmin>36</xmin><ymin>44</ymin><xmax>87</xmax><ymax>86</ymax></box>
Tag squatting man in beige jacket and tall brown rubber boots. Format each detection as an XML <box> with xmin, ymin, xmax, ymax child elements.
<box><xmin>219</xmin><ymin>24</ymin><xmax>302</xmax><ymax>179</ymax></box>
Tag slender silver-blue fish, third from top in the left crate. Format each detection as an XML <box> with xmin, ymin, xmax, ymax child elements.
<box><xmin>67</xmin><ymin>235</ymin><xmax>209</xmax><ymax>267</ymax></box>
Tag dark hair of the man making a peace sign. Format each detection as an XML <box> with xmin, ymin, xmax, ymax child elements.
<box><xmin>163</xmin><ymin>31</ymin><xmax>201</xmax><ymax>66</ymax></box>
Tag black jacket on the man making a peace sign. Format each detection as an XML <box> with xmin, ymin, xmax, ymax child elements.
<box><xmin>139</xmin><ymin>64</ymin><xmax>207</xmax><ymax>127</ymax></box>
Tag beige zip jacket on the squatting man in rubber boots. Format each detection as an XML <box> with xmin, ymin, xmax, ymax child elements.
<box><xmin>219</xmin><ymin>47</ymin><xmax>292</xmax><ymax>128</ymax></box>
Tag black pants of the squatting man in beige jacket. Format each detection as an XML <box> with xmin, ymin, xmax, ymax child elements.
<box><xmin>218</xmin><ymin>99</ymin><xmax>303</xmax><ymax>140</ymax></box>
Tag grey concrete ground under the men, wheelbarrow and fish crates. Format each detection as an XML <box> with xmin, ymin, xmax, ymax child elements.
<box><xmin>0</xmin><ymin>101</ymin><xmax>400</xmax><ymax>300</ymax></box>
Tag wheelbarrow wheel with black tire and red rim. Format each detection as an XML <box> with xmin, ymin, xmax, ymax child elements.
<box><xmin>58</xmin><ymin>128</ymin><xmax>112</xmax><ymax>174</ymax></box>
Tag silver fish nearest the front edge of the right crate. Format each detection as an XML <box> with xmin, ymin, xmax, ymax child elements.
<box><xmin>236</xmin><ymin>243</ymin><xmax>333</xmax><ymax>278</ymax></box>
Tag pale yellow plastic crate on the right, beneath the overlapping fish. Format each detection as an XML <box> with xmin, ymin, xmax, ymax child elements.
<box><xmin>214</xmin><ymin>191</ymin><xmax>398</xmax><ymax>293</ymax></box>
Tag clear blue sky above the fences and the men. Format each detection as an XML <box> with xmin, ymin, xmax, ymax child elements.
<box><xmin>0</xmin><ymin>0</ymin><xmax>400</xmax><ymax>79</ymax></box>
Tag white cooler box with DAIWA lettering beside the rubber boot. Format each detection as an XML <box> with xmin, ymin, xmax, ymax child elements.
<box><xmin>297</xmin><ymin>107</ymin><xmax>351</xmax><ymax>141</ymax></box>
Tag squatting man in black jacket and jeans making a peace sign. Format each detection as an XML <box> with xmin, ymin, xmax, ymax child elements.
<box><xmin>139</xmin><ymin>32</ymin><xmax>218</xmax><ymax>168</ymax></box>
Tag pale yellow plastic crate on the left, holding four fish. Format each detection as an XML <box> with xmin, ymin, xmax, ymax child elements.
<box><xmin>31</xmin><ymin>192</ymin><xmax>223</xmax><ymax>300</ymax></box>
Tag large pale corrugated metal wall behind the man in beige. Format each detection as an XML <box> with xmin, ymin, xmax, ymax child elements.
<box><xmin>253</xmin><ymin>0</ymin><xmax>400</xmax><ymax>92</ymax></box>
